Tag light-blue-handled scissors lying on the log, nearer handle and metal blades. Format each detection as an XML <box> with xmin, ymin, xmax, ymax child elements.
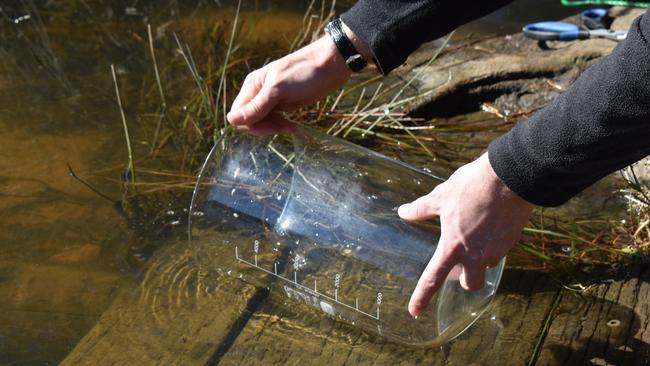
<box><xmin>523</xmin><ymin>22</ymin><xmax>627</xmax><ymax>42</ymax></box>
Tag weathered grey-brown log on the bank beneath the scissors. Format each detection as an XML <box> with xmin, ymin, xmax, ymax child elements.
<box><xmin>405</xmin><ymin>8</ymin><xmax>643</xmax><ymax>117</ymax></box>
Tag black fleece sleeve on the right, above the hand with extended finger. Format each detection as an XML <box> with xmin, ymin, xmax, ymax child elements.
<box><xmin>489</xmin><ymin>10</ymin><xmax>650</xmax><ymax>206</ymax></box>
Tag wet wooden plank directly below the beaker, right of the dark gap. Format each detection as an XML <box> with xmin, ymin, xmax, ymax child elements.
<box><xmin>213</xmin><ymin>270</ymin><xmax>557</xmax><ymax>365</ymax></box>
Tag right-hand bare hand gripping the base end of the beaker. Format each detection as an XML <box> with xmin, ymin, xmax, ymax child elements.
<box><xmin>398</xmin><ymin>153</ymin><xmax>533</xmax><ymax>316</ymax></box>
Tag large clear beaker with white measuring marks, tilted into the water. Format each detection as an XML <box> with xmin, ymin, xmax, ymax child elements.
<box><xmin>190</xmin><ymin>125</ymin><xmax>503</xmax><ymax>345</ymax></box>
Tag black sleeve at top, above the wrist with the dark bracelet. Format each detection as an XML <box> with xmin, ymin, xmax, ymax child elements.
<box><xmin>341</xmin><ymin>0</ymin><xmax>512</xmax><ymax>74</ymax></box>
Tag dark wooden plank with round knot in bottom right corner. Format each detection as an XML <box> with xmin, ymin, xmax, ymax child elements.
<box><xmin>537</xmin><ymin>266</ymin><xmax>650</xmax><ymax>365</ymax></box>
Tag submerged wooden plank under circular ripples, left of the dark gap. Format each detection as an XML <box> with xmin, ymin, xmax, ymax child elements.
<box><xmin>63</xmin><ymin>244</ymin><xmax>265</xmax><ymax>365</ymax></box>
